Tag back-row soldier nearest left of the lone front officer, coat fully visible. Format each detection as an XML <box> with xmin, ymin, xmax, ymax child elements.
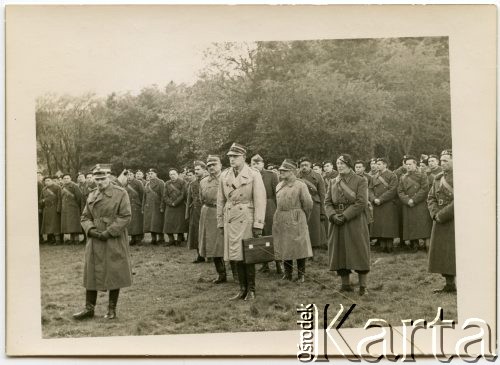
<box><xmin>61</xmin><ymin>174</ymin><xmax>85</xmax><ymax>244</ymax></box>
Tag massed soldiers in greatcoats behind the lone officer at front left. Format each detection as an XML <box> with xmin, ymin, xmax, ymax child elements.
<box><xmin>39</xmin><ymin>143</ymin><xmax>456</xmax><ymax>319</ymax></box>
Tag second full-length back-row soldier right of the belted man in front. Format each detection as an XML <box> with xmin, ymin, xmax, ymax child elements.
<box><xmin>398</xmin><ymin>156</ymin><xmax>432</xmax><ymax>252</ymax></box>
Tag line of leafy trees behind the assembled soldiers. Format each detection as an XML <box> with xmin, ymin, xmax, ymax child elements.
<box><xmin>36</xmin><ymin>37</ymin><xmax>451</xmax><ymax>179</ymax></box>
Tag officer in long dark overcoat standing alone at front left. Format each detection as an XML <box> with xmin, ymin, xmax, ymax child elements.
<box><xmin>73</xmin><ymin>168</ymin><xmax>132</xmax><ymax>320</ymax></box>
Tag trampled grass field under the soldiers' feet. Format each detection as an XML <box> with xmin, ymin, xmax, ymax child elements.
<box><xmin>40</xmin><ymin>236</ymin><xmax>457</xmax><ymax>338</ymax></box>
